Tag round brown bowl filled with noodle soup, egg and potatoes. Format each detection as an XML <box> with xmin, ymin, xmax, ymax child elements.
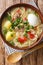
<box><xmin>0</xmin><ymin>3</ymin><xmax>43</xmax><ymax>50</ymax></box>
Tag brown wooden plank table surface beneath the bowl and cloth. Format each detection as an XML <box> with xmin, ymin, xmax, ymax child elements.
<box><xmin>0</xmin><ymin>0</ymin><xmax>43</xmax><ymax>65</ymax></box>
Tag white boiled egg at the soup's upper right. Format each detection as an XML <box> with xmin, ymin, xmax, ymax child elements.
<box><xmin>28</xmin><ymin>13</ymin><xmax>41</xmax><ymax>26</ymax></box>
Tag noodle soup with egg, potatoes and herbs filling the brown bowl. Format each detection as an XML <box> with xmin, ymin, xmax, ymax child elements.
<box><xmin>2</xmin><ymin>7</ymin><xmax>43</xmax><ymax>48</ymax></box>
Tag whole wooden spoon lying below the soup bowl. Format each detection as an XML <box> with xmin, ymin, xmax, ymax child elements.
<box><xmin>7</xmin><ymin>43</ymin><xmax>43</xmax><ymax>63</ymax></box>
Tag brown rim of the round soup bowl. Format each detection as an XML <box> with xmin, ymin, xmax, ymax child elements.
<box><xmin>0</xmin><ymin>3</ymin><xmax>43</xmax><ymax>50</ymax></box>
